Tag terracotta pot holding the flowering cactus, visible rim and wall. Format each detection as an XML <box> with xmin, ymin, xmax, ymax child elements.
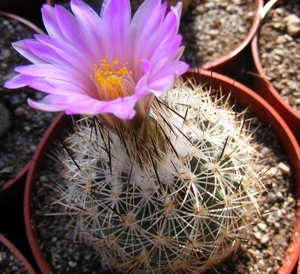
<box><xmin>24</xmin><ymin>70</ymin><xmax>300</xmax><ymax>274</ymax></box>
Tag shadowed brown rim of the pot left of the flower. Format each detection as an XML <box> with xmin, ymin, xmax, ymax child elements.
<box><xmin>0</xmin><ymin>11</ymin><xmax>44</xmax><ymax>195</ymax></box>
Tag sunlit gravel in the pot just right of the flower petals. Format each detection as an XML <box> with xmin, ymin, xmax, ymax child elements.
<box><xmin>180</xmin><ymin>0</ymin><xmax>254</xmax><ymax>67</ymax></box>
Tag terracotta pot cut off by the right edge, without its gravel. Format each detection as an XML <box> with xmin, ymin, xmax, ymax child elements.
<box><xmin>251</xmin><ymin>0</ymin><xmax>300</xmax><ymax>144</ymax></box>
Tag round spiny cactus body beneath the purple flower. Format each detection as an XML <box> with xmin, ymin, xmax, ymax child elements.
<box><xmin>52</xmin><ymin>82</ymin><xmax>264</xmax><ymax>273</ymax></box>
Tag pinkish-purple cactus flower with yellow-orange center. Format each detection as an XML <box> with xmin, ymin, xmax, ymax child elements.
<box><xmin>5</xmin><ymin>0</ymin><xmax>188</xmax><ymax>119</ymax></box>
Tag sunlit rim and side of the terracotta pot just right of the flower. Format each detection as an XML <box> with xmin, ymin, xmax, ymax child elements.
<box><xmin>197</xmin><ymin>0</ymin><xmax>264</xmax><ymax>77</ymax></box>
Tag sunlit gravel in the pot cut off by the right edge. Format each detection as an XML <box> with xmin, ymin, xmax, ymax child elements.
<box><xmin>258</xmin><ymin>0</ymin><xmax>300</xmax><ymax>114</ymax></box>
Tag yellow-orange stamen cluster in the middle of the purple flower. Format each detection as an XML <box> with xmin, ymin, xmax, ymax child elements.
<box><xmin>90</xmin><ymin>58</ymin><xmax>133</xmax><ymax>101</ymax></box>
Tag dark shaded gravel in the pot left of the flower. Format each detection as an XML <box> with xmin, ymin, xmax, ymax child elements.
<box><xmin>0</xmin><ymin>16</ymin><xmax>54</xmax><ymax>187</ymax></box>
